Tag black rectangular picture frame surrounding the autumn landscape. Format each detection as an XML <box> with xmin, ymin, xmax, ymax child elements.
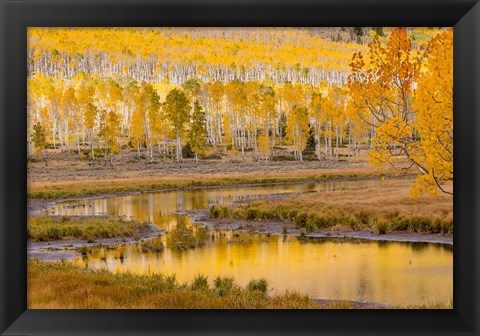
<box><xmin>0</xmin><ymin>0</ymin><xmax>480</xmax><ymax>335</ymax></box>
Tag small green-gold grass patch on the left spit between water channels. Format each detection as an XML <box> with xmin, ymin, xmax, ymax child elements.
<box><xmin>27</xmin><ymin>216</ymin><xmax>150</xmax><ymax>241</ymax></box>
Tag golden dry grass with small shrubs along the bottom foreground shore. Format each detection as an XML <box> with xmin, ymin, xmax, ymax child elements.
<box><xmin>28</xmin><ymin>260</ymin><xmax>318</xmax><ymax>309</ymax></box>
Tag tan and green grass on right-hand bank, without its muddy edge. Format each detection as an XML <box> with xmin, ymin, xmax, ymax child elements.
<box><xmin>210</xmin><ymin>180</ymin><xmax>453</xmax><ymax>234</ymax></box>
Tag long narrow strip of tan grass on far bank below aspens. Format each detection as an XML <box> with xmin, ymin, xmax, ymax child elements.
<box><xmin>27</xmin><ymin>160</ymin><xmax>404</xmax><ymax>200</ymax></box>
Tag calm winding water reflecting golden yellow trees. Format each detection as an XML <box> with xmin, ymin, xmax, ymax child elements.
<box><xmin>50</xmin><ymin>181</ymin><xmax>453</xmax><ymax>305</ymax></box>
